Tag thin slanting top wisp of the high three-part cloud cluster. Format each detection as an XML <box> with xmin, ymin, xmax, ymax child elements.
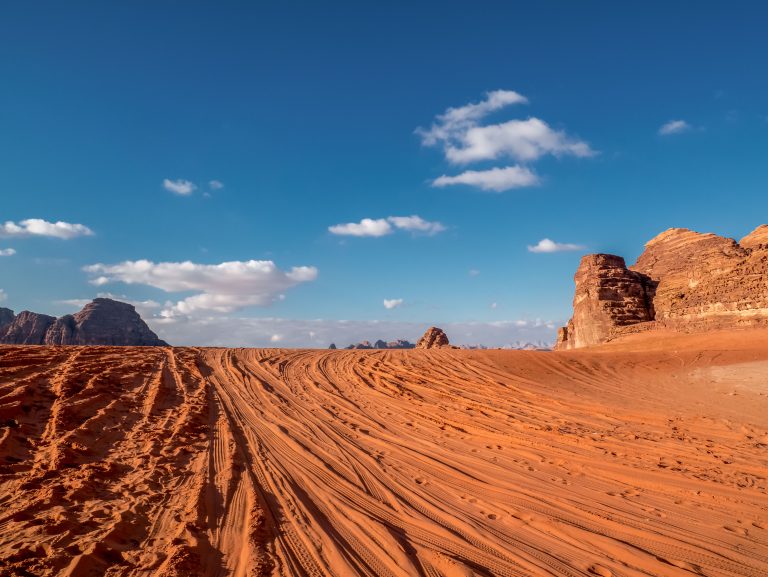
<box><xmin>416</xmin><ymin>90</ymin><xmax>528</xmax><ymax>146</ymax></box>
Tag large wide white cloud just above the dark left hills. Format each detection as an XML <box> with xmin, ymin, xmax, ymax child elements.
<box><xmin>84</xmin><ymin>260</ymin><xmax>317</xmax><ymax>317</ymax></box>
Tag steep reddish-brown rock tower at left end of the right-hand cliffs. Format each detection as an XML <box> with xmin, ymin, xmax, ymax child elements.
<box><xmin>557</xmin><ymin>254</ymin><xmax>654</xmax><ymax>349</ymax></box>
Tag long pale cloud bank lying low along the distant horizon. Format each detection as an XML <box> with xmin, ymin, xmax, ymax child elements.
<box><xmin>146</xmin><ymin>316</ymin><xmax>562</xmax><ymax>348</ymax></box>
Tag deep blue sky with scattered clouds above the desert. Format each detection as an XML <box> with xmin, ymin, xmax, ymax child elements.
<box><xmin>0</xmin><ymin>1</ymin><xmax>768</xmax><ymax>346</ymax></box>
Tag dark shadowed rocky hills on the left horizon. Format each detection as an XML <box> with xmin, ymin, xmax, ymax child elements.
<box><xmin>0</xmin><ymin>298</ymin><xmax>168</xmax><ymax>346</ymax></box>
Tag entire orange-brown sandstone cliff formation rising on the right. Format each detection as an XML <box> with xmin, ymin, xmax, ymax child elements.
<box><xmin>557</xmin><ymin>225</ymin><xmax>768</xmax><ymax>349</ymax></box>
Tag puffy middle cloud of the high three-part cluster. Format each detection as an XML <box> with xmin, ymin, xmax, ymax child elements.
<box><xmin>445</xmin><ymin>118</ymin><xmax>595</xmax><ymax>164</ymax></box>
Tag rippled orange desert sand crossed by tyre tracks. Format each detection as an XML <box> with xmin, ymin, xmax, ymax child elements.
<box><xmin>0</xmin><ymin>330</ymin><xmax>768</xmax><ymax>577</ymax></box>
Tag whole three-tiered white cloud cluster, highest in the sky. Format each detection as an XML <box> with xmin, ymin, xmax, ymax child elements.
<box><xmin>416</xmin><ymin>90</ymin><xmax>597</xmax><ymax>192</ymax></box>
